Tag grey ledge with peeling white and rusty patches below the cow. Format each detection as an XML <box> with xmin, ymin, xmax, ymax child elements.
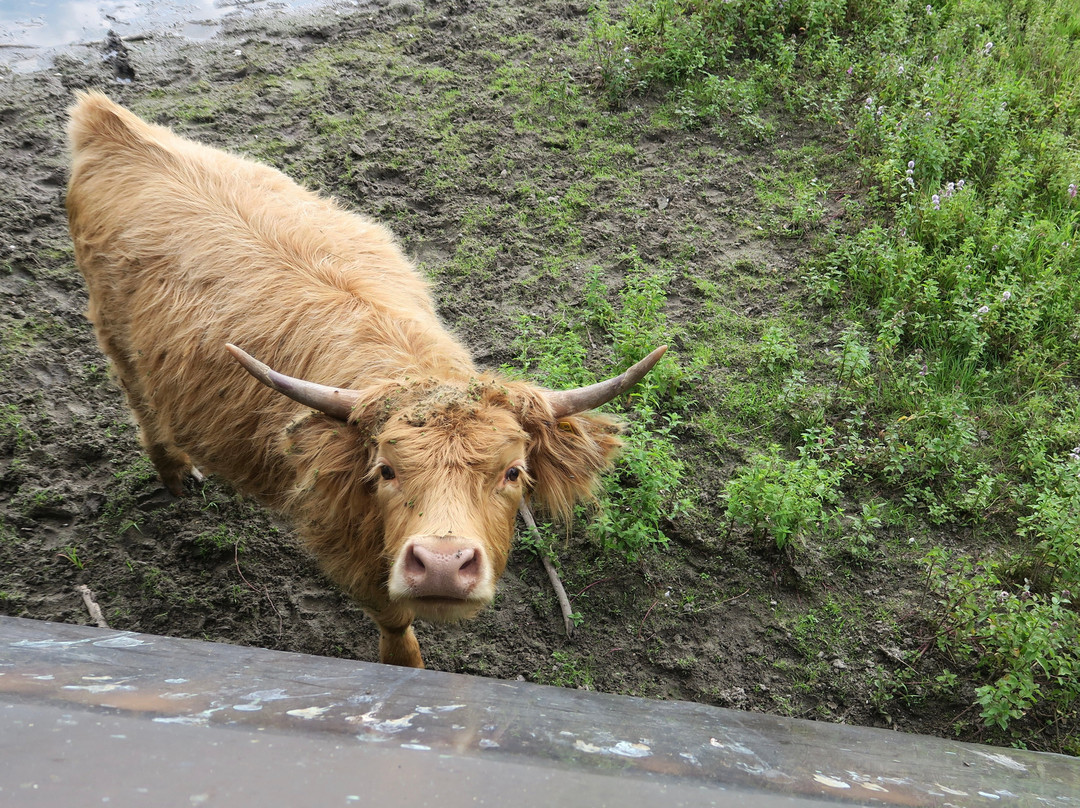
<box><xmin>0</xmin><ymin>618</ymin><xmax>1080</xmax><ymax>808</ymax></box>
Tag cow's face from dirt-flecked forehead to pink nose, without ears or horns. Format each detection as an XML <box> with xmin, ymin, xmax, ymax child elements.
<box><xmin>368</xmin><ymin>398</ymin><xmax>530</xmax><ymax>620</ymax></box>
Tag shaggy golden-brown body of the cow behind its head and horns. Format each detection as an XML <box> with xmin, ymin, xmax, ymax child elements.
<box><xmin>67</xmin><ymin>93</ymin><xmax>472</xmax><ymax>501</ymax></box>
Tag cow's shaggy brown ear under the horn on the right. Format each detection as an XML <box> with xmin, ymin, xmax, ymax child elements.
<box><xmin>524</xmin><ymin>413</ymin><xmax>622</xmax><ymax>519</ymax></box>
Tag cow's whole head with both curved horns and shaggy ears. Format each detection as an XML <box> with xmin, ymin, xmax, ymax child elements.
<box><xmin>229</xmin><ymin>346</ymin><xmax>665</xmax><ymax>620</ymax></box>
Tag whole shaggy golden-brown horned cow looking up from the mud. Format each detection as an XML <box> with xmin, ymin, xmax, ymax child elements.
<box><xmin>67</xmin><ymin>93</ymin><xmax>663</xmax><ymax>666</ymax></box>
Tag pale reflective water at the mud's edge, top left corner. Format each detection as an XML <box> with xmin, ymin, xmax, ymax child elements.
<box><xmin>0</xmin><ymin>0</ymin><xmax>345</xmax><ymax>72</ymax></box>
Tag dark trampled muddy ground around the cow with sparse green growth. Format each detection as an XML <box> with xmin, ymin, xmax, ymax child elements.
<box><xmin>0</xmin><ymin>0</ymin><xmax>993</xmax><ymax>740</ymax></box>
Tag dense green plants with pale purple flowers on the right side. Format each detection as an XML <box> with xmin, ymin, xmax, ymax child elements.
<box><xmin>586</xmin><ymin>0</ymin><xmax>1080</xmax><ymax>751</ymax></box>
